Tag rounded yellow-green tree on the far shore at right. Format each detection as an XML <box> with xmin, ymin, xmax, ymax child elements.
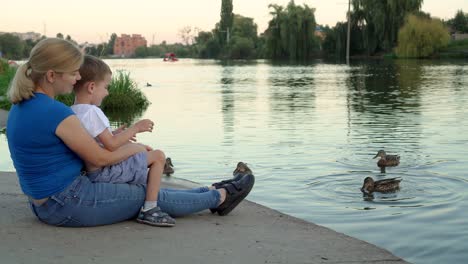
<box><xmin>395</xmin><ymin>15</ymin><xmax>450</xmax><ymax>58</ymax></box>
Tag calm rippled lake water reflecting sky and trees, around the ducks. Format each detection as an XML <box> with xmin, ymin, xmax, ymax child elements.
<box><xmin>0</xmin><ymin>59</ymin><xmax>468</xmax><ymax>263</ymax></box>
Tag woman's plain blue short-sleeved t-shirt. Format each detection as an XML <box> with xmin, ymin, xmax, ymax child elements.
<box><xmin>6</xmin><ymin>93</ymin><xmax>83</xmax><ymax>199</ymax></box>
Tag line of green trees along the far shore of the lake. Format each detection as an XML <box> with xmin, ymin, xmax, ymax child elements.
<box><xmin>0</xmin><ymin>0</ymin><xmax>468</xmax><ymax>60</ymax></box>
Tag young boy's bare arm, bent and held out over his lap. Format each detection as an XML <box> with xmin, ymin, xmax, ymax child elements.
<box><xmin>97</xmin><ymin>119</ymin><xmax>154</xmax><ymax>151</ymax></box>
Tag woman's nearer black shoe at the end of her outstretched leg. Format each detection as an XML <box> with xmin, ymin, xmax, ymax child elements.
<box><xmin>215</xmin><ymin>174</ymin><xmax>255</xmax><ymax>216</ymax></box>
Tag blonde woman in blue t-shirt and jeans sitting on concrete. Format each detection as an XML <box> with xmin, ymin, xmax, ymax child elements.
<box><xmin>7</xmin><ymin>38</ymin><xmax>254</xmax><ymax>226</ymax></box>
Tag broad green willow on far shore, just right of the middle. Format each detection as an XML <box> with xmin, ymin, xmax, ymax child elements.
<box><xmin>265</xmin><ymin>0</ymin><xmax>318</xmax><ymax>60</ymax></box>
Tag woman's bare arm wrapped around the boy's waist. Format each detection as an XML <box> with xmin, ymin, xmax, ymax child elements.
<box><xmin>55</xmin><ymin>115</ymin><xmax>146</xmax><ymax>167</ymax></box>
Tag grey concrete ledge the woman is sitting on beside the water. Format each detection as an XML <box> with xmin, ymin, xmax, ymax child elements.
<box><xmin>0</xmin><ymin>172</ymin><xmax>407</xmax><ymax>264</ymax></box>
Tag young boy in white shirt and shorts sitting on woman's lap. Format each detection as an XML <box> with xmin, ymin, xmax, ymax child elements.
<box><xmin>71</xmin><ymin>55</ymin><xmax>175</xmax><ymax>226</ymax></box>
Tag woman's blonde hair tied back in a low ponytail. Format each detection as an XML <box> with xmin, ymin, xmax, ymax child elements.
<box><xmin>8</xmin><ymin>38</ymin><xmax>83</xmax><ymax>104</ymax></box>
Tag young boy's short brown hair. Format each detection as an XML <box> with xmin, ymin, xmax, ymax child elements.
<box><xmin>75</xmin><ymin>55</ymin><xmax>112</xmax><ymax>89</ymax></box>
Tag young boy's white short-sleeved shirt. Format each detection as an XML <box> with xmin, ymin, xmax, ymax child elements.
<box><xmin>71</xmin><ymin>104</ymin><xmax>112</xmax><ymax>140</ymax></box>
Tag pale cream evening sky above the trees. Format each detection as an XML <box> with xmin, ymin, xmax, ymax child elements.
<box><xmin>0</xmin><ymin>0</ymin><xmax>468</xmax><ymax>44</ymax></box>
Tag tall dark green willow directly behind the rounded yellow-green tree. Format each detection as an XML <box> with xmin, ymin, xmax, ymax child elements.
<box><xmin>352</xmin><ymin>0</ymin><xmax>423</xmax><ymax>54</ymax></box>
